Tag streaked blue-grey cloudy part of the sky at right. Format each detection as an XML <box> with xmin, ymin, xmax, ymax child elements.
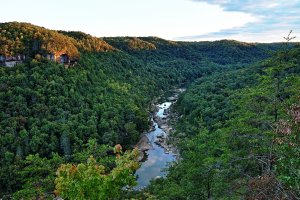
<box><xmin>179</xmin><ymin>0</ymin><xmax>300</xmax><ymax>42</ymax></box>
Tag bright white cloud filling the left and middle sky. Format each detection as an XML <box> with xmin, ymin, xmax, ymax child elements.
<box><xmin>0</xmin><ymin>0</ymin><xmax>257</xmax><ymax>39</ymax></box>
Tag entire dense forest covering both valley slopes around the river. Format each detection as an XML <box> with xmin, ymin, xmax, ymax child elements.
<box><xmin>0</xmin><ymin>22</ymin><xmax>300</xmax><ymax>199</ymax></box>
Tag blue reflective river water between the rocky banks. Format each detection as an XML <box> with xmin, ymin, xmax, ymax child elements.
<box><xmin>135</xmin><ymin>102</ymin><xmax>176</xmax><ymax>189</ymax></box>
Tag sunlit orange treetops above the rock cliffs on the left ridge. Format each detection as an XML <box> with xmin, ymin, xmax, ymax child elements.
<box><xmin>0</xmin><ymin>22</ymin><xmax>80</xmax><ymax>59</ymax></box>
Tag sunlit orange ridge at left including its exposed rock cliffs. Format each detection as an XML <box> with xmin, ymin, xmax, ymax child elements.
<box><xmin>0</xmin><ymin>22</ymin><xmax>113</xmax><ymax>67</ymax></box>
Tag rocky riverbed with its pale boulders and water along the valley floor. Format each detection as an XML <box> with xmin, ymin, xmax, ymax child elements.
<box><xmin>135</xmin><ymin>90</ymin><xmax>184</xmax><ymax>190</ymax></box>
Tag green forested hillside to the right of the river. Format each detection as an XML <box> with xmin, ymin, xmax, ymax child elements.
<box><xmin>149</xmin><ymin>43</ymin><xmax>300</xmax><ymax>199</ymax></box>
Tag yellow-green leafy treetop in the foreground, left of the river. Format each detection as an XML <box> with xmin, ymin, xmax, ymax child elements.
<box><xmin>55</xmin><ymin>148</ymin><xmax>139</xmax><ymax>199</ymax></box>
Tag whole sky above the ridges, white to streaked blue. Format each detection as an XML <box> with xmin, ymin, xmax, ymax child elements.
<box><xmin>0</xmin><ymin>0</ymin><xmax>300</xmax><ymax>42</ymax></box>
